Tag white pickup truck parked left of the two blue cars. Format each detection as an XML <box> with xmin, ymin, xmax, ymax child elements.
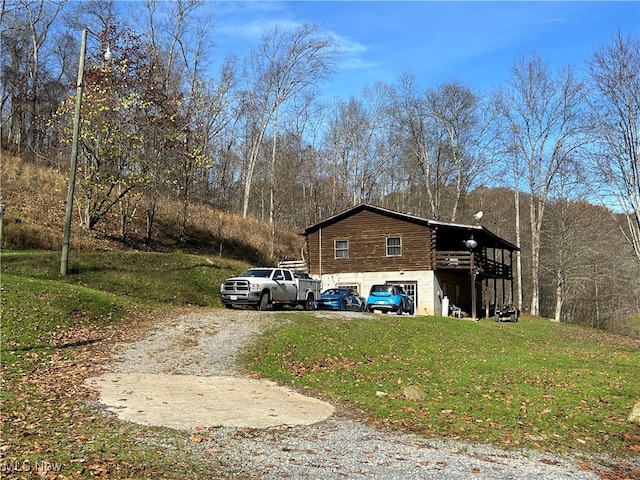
<box><xmin>220</xmin><ymin>267</ymin><xmax>321</xmax><ymax>310</ymax></box>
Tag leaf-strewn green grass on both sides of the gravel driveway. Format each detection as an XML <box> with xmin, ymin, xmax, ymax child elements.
<box><xmin>0</xmin><ymin>251</ymin><xmax>640</xmax><ymax>479</ymax></box>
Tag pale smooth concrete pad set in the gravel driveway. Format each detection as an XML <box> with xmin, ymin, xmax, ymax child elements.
<box><xmin>87</xmin><ymin>373</ymin><xmax>334</xmax><ymax>430</ymax></box>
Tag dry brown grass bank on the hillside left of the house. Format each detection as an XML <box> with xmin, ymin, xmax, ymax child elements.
<box><xmin>0</xmin><ymin>153</ymin><xmax>304</xmax><ymax>264</ymax></box>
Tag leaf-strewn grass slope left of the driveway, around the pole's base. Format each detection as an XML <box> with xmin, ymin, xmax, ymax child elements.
<box><xmin>0</xmin><ymin>251</ymin><xmax>245</xmax><ymax>479</ymax></box>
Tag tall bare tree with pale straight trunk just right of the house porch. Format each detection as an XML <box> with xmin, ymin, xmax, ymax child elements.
<box><xmin>498</xmin><ymin>55</ymin><xmax>584</xmax><ymax>315</ymax></box>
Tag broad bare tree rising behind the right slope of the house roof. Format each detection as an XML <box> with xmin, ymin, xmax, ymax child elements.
<box><xmin>394</xmin><ymin>73</ymin><xmax>492</xmax><ymax>222</ymax></box>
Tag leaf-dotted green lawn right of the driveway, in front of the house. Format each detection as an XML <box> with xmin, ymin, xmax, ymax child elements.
<box><xmin>242</xmin><ymin>314</ymin><xmax>640</xmax><ymax>455</ymax></box>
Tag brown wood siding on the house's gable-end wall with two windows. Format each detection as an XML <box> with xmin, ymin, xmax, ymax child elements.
<box><xmin>307</xmin><ymin>210</ymin><xmax>432</xmax><ymax>275</ymax></box>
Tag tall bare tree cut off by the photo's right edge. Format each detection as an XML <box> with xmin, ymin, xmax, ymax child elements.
<box><xmin>588</xmin><ymin>32</ymin><xmax>640</xmax><ymax>261</ymax></box>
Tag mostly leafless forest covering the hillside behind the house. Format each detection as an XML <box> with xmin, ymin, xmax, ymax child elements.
<box><xmin>0</xmin><ymin>0</ymin><xmax>640</xmax><ymax>336</ymax></box>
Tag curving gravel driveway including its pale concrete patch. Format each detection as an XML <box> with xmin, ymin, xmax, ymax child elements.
<box><xmin>88</xmin><ymin>310</ymin><xmax>616</xmax><ymax>480</ymax></box>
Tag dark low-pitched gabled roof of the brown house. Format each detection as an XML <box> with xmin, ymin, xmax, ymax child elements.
<box><xmin>301</xmin><ymin>203</ymin><xmax>520</xmax><ymax>250</ymax></box>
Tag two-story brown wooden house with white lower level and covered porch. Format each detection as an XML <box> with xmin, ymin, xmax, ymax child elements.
<box><xmin>301</xmin><ymin>204</ymin><xmax>518</xmax><ymax>318</ymax></box>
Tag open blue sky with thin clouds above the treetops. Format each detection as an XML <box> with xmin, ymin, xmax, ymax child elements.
<box><xmin>209</xmin><ymin>0</ymin><xmax>640</xmax><ymax>100</ymax></box>
